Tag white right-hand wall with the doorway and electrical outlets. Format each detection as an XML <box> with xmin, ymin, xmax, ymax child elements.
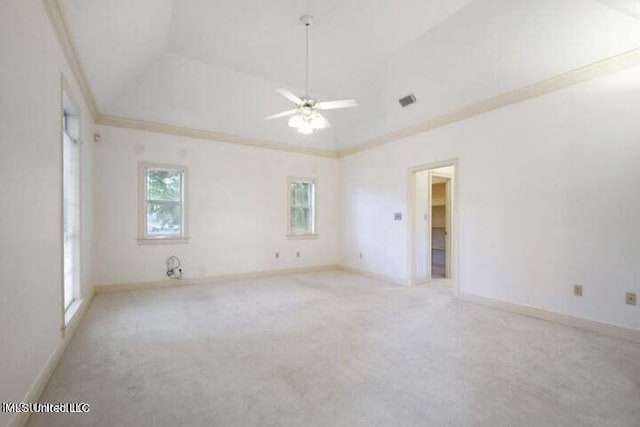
<box><xmin>340</xmin><ymin>64</ymin><xmax>640</xmax><ymax>328</ymax></box>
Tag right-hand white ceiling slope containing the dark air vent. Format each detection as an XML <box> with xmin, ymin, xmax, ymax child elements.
<box><xmin>335</xmin><ymin>0</ymin><xmax>640</xmax><ymax>148</ymax></box>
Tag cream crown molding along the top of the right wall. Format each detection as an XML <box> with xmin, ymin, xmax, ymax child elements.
<box><xmin>338</xmin><ymin>48</ymin><xmax>640</xmax><ymax>158</ymax></box>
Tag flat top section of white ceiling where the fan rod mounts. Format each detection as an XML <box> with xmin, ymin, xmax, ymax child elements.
<box><xmin>168</xmin><ymin>0</ymin><xmax>472</xmax><ymax>91</ymax></box>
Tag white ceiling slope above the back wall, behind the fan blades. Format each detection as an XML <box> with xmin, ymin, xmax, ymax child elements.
<box><xmin>104</xmin><ymin>54</ymin><xmax>335</xmax><ymax>150</ymax></box>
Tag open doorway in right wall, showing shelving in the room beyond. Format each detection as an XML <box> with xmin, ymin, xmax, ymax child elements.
<box><xmin>409</xmin><ymin>161</ymin><xmax>457</xmax><ymax>292</ymax></box>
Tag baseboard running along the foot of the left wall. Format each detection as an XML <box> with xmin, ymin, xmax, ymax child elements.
<box><xmin>7</xmin><ymin>294</ymin><xmax>94</xmax><ymax>427</ymax></box>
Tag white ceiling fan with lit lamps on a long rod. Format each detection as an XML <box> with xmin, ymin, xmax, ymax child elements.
<box><xmin>265</xmin><ymin>15</ymin><xmax>358</xmax><ymax>135</ymax></box>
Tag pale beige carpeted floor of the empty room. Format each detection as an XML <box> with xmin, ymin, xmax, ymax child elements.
<box><xmin>29</xmin><ymin>272</ymin><xmax>640</xmax><ymax>427</ymax></box>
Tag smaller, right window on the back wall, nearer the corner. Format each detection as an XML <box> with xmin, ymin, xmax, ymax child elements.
<box><xmin>289</xmin><ymin>178</ymin><xmax>316</xmax><ymax>237</ymax></box>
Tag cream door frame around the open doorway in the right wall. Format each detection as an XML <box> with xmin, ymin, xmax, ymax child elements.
<box><xmin>407</xmin><ymin>158</ymin><xmax>460</xmax><ymax>296</ymax></box>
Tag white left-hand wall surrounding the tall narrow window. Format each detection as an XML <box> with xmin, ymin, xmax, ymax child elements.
<box><xmin>0</xmin><ymin>0</ymin><xmax>93</xmax><ymax>425</ymax></box>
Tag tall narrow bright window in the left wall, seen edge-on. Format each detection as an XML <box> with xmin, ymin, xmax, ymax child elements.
<box><xmin>62</xmin><ymin>94</ymin><xmax>80</xmax><ymax>312</ymax></box>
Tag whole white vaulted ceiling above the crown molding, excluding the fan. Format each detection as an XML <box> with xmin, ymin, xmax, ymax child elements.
<box><xmin>61</xmin><ymin>0</ymin><xmax>640</xmax><ymax>149</ymax></box>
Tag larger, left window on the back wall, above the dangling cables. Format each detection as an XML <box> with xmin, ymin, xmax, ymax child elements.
<box><xmin>140</xmin><ymin>164</ymin><xmax>187</xmax><ymax>240</ymax></box>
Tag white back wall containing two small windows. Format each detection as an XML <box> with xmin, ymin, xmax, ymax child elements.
<box><xmin>94</xmin><ymin>126</ymin><xmax>338</xmax><ymax>285</ymax></box>
